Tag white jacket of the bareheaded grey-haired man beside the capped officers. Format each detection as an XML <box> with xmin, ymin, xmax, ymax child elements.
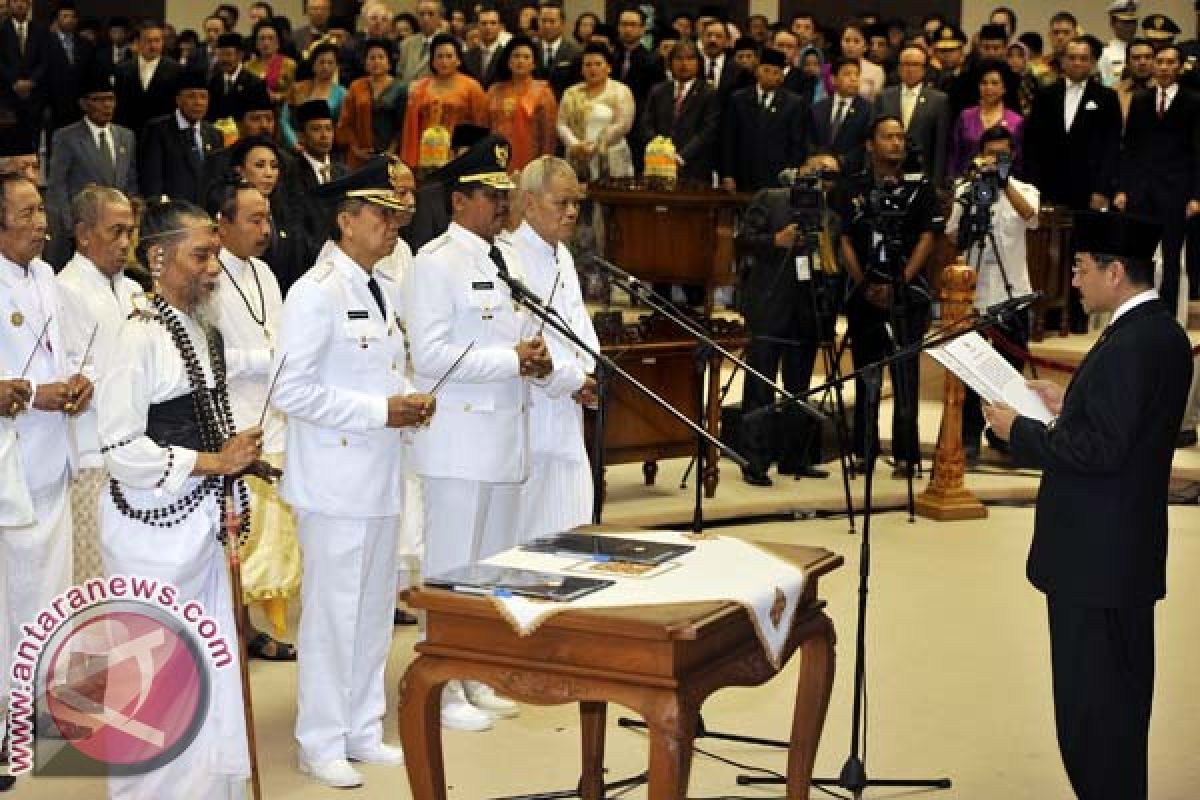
<box><xmin>500</xmin><ymin>223</ymin><xmax>600</xmax><ymax>462</ymax></box>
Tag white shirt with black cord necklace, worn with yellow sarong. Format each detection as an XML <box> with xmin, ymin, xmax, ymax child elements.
<box><xmin>205</xmin><ymin>247</ymin><xmax>286</xmax><ymax>453</ymax></box>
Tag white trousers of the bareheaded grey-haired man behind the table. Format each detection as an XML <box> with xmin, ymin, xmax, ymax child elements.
<box><xmin>517</xmin><ymin>453</ymin><xmax>593</xmax><ymax>543</ymax></box>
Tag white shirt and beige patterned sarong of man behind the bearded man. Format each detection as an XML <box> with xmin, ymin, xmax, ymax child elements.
<box><xmin>58</xmin><ymin>253</ymin><xmax>142</xmax><ymax>584</ymax></box>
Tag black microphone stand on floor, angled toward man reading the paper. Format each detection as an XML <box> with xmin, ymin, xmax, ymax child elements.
<box><xmin>737</xmin><ymin>303</ymin><xmax>1037</xmax><ymax>800</ymax></box>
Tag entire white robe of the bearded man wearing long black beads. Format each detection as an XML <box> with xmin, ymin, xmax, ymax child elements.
<box><xmin>96</xmin><ymin>303</ymin><xmax>250</xmax><ymax>800</ymax></box>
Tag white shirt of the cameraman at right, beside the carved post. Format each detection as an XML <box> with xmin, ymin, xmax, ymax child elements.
<box><xmin>946</xmin><ymin>178</ymin><xmax>1042</xmax><ymax>311</ymax></box>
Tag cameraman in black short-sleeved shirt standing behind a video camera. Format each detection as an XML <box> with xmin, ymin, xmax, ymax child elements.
<box><xmin>834</xmin><ymin>115</ymin><xmax>944</xmax><ymax>477</ymax></box>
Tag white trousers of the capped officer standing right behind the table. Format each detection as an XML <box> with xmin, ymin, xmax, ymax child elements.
<box><xmin>421</xmin><ymin>477</ymin><xmax>521</xmax><ymax>577</ymax></box>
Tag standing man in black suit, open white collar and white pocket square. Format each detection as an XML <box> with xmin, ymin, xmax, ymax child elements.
<box><xmin>1025</xmin><ymin>37</ymin><xmax>1121</xmax><ymax>211</ymax></box>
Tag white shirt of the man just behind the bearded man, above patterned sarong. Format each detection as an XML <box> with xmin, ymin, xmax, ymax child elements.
<box><xmin>58</xmin><ymin>253</ymin><xmax>142</xmax><ymax>469</ymax></box>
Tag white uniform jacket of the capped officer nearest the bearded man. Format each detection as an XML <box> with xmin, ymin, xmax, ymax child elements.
<box><xmin>272</xmin><ymin>247</ymin><xmax>409</xmax><ymax>518</ymax></box>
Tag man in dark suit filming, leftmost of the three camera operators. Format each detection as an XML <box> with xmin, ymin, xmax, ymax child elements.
<box><xmin>737</xmin><ymin>155</ymin><xmax>838</xmax><ymax>486</ymax></box>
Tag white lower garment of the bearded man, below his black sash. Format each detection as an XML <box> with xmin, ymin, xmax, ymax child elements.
<box><xmin>100</xmin><ymin>487</ymin><xmax>250</xmax><ymax>800</ymax></box>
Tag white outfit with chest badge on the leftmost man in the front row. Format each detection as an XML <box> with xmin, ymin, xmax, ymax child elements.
<box><xmin>0</xmin><ymin>255</ymin><xmax>74</xmax><ymax>724</ymax></box>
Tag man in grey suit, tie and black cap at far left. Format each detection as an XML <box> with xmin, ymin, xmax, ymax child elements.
<box><xmin>46</xmin><ymin>68</ymin><xmax>139</xmax><ymax>266</ymax></box>
